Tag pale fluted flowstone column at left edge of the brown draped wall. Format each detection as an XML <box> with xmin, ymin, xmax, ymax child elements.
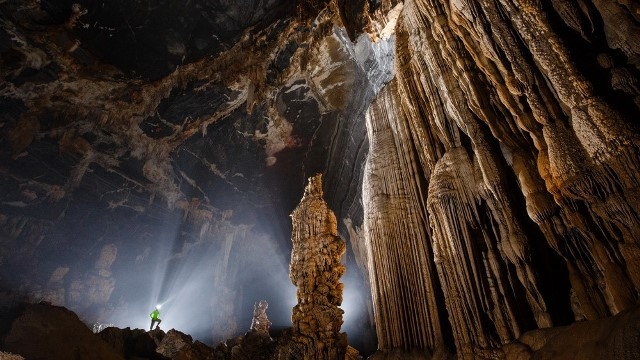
<box><xmin>363</xmin><ymin>84</ymin><xmax>443</xmax><ymax>349</ymax></box>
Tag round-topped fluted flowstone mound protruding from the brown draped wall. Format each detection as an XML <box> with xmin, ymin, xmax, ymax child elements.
<box><xmin>428</xmin><ymin>148</ymin><xmax>526</xmax><ymax>358</ymax></box>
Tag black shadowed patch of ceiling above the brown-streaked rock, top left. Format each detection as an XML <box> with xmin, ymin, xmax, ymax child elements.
<box><xmin>41</xmin><ymin>0</ymin><xmax>293</xmax><ymax>79</ymax></box>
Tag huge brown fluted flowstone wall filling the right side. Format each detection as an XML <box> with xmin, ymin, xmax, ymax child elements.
<box><xmin>363</xmin><ymin>0</ymin><xmax>640</xmax><ymax>358</ymax></box>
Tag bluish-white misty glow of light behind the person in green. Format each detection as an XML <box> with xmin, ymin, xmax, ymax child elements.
<box><xmin>104</xmin><ymin>214</ymin><xmax>296</xmax><ymax>344</ymax></box>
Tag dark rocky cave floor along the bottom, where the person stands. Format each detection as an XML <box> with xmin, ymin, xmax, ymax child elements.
<box><xmin>0</xmin><ymin>303</ymin><xmax>640</xmax><ymax>360</ymax></box>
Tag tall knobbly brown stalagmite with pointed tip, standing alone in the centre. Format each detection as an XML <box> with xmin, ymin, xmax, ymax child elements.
<box><xmin>288</xmin><ymin>174</ymin><xmax>347</xmax><ymax>360</ymax></box>
